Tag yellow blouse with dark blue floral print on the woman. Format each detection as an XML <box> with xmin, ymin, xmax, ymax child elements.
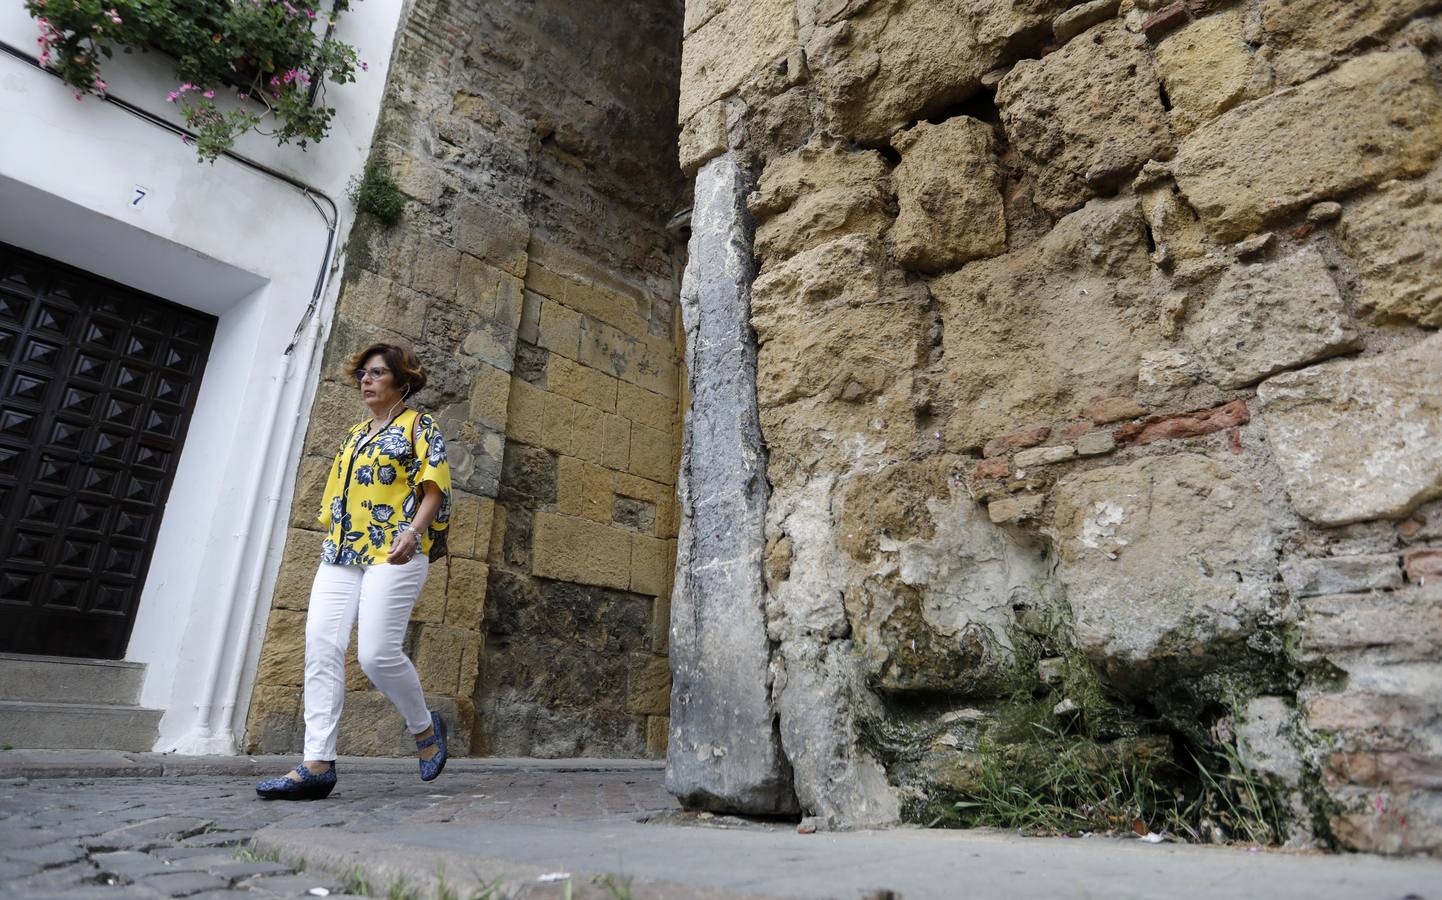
<box><xmin>317</xmin><ymin>410</ymin><xmax>450</xmax><ymax>565</ymax></box>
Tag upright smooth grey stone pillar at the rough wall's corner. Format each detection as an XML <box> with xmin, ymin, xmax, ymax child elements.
<box><xmin>666</xmin><ymin>154</ymin><xmax>796</xmax><ymax>813</ymax></box>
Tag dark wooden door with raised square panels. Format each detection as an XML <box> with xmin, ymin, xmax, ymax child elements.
<box><xmin>0</xmin><ymin>244</ymin><xmax>215</xmax><ymax>659</ymax></box>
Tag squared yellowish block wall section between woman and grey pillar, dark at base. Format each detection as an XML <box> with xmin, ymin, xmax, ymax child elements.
<box><xmin>477</xmin><ymin>239</ymin><xmax>679</xmax><ymax>756</ymax></box>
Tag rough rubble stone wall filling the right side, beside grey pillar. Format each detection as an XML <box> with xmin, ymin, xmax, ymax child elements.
<box><xmin>672</xmin><ymin>0</ymin><xmax>1442</xmax><ymax>852</ymax></box>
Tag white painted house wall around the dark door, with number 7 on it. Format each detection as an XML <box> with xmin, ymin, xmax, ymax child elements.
<box><xmin>0</xmin><ymin>0</ymin><xmax>404</xmax><ymax>753</ymax></box>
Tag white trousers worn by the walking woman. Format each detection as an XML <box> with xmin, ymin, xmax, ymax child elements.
<box><xmin>306</xmin><ymin>555</ymin><xmax>431</xmax><ymax>760</ymax></box>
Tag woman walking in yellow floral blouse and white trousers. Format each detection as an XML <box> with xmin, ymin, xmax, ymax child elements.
<box><xmin>255</xmin><ymin>343</ymin><xmax>450</xmax><ymax>800</ymax></box>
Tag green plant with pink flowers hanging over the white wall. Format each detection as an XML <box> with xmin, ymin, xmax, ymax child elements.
<box><xmin>25</xmin><ymin>0</ymin><xmax>366</xmax><ymax>160</ymax></box>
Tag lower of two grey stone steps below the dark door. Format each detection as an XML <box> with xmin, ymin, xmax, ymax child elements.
<box><xmin>0</xmin><ymin>700</ymin><xmax>162</xmax><ymax>751</ymax></box>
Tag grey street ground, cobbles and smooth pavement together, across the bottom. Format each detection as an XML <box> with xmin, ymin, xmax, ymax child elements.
<box><xmin>0</xmin><ymin>751</ymin><xmax>1442</xmax><ymax>900</ymax></box>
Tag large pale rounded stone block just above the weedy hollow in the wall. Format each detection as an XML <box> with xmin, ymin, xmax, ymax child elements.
<box><xmin>1054</xmin><ymin>454</ymin><xmax>1278</xmax><ymax>678</ymax></box>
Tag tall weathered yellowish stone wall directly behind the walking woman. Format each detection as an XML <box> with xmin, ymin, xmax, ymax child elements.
<box><xmin>247</xmin><ymin>0</ymin><xmax>685</xmax><ymax>756</ymax></box>
